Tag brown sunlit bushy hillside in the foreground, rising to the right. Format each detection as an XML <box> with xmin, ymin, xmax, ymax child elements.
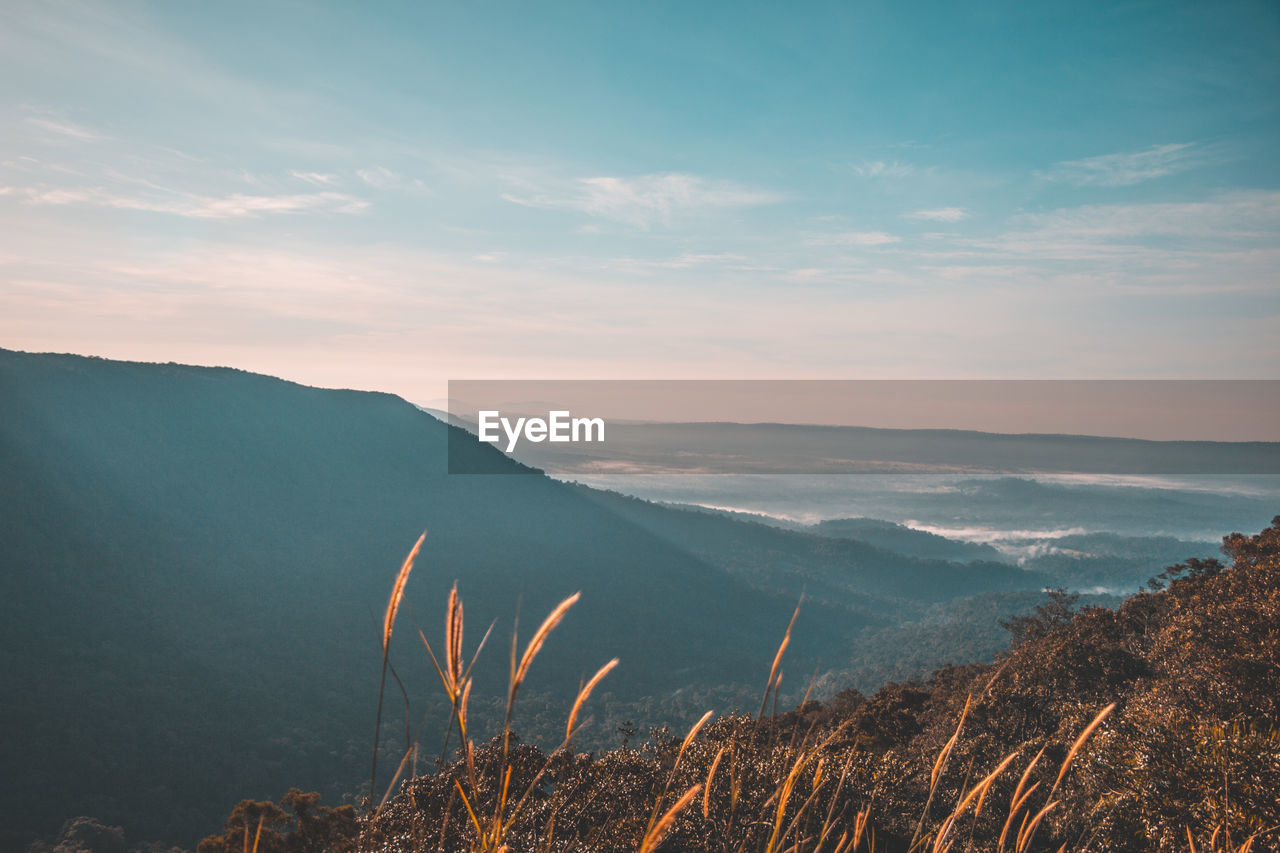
<box><xmin>200</xmin><ymin>516</ymin><xmax>1280</xmax><ymax>853</ymax></box>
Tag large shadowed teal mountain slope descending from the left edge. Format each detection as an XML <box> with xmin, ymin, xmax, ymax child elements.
<box><xmin>0</xmin><ymin>351</ymin><xmax>1043</xmax><ymax>848</ymax></box>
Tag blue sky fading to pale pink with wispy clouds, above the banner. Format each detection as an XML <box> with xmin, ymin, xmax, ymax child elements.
<box><xmin>0</xmin><ymin>0</ymin><xmax>1280</xmax><ymax>402</ymax></box>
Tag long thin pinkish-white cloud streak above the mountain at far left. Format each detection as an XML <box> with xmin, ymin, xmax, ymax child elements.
<box><xmin>20</xmin><ymin>187</ymin><xmax>369</xmax><ymax>219</ymax></box>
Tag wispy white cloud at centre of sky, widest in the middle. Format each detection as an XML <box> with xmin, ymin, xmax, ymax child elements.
<box><xmin>503</xmin><ymin>173</ymin><xmax>781</xmax><ymax>228</ymax></box>
